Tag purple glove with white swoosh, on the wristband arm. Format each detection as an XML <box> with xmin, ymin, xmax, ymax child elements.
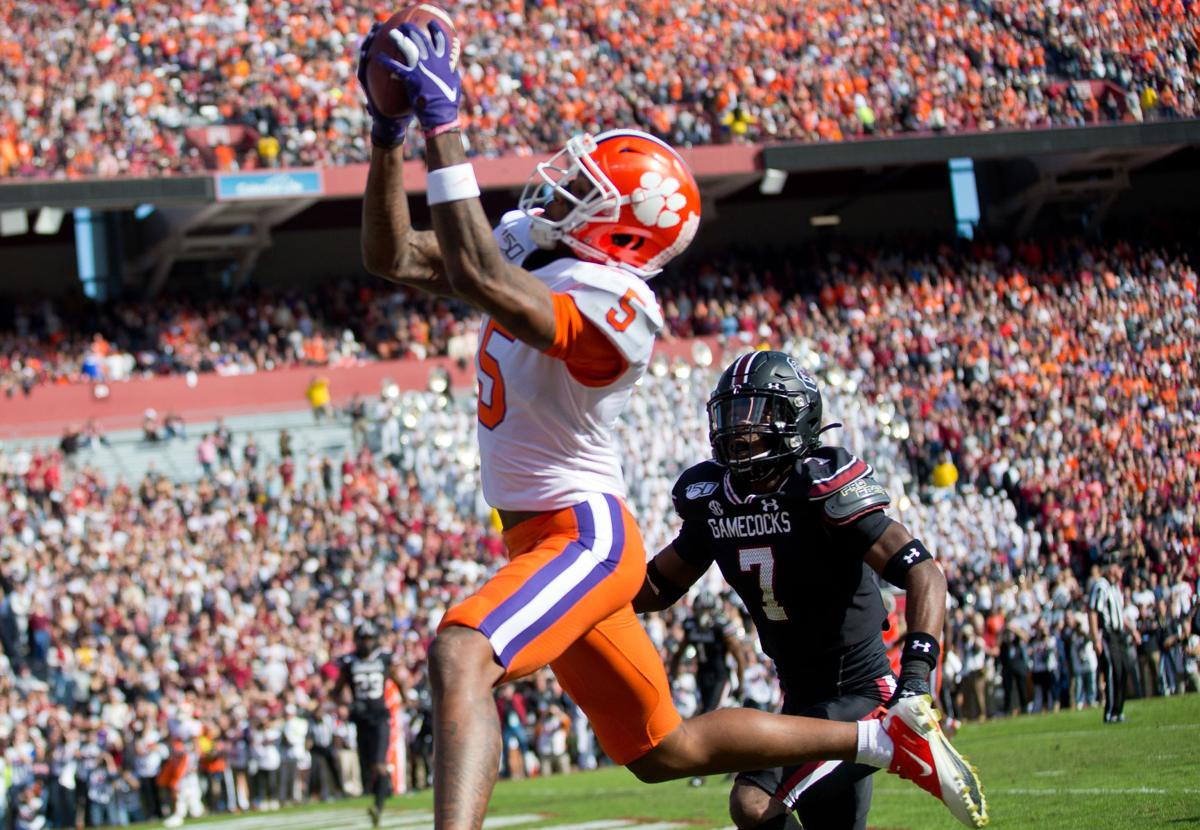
<box><xmin>386</xmin><ymin>20</ymin><xmax>462</xmax><ymax>133</ymax></box>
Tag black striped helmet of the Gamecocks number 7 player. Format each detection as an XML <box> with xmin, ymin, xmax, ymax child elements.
<box><xmin>708</xmin><ymin>351</ymin><xmax>821</xmax><ymax>485</ymax></box>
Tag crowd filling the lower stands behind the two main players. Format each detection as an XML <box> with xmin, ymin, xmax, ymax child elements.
<box><xmin>0</xmin><ymin>241</ymin><xmax>1200</xmax><ymax>830</ymax></box>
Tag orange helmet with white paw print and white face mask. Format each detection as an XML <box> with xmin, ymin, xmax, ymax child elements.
<box><xmin>520</xmin><ymin>130</ymin><xmax>700</xmax><ymax>279</ymax></box>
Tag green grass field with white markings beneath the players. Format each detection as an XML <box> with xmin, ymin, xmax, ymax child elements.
<box><xmin>174</xmin><ymin>694</ymin><xmax>1200</xmax><ymax>830</ymax></box>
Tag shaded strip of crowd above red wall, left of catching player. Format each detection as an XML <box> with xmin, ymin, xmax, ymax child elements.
<box><xmin>0</xmin><ymin>281</ymin><xmax>475</xmax><ymax>397</ymax></box>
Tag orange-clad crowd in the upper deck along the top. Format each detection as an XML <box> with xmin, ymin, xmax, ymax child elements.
<box><xmin>0</xmin><ymin>0</ymin><xmax>1200</xmax><ymax>178</ymax></box>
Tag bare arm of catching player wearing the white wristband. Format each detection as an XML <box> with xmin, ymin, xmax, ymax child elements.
<box><xmin>427</xmin><ymin>132</ymin><xmax>556</xmax><ymax>349</ymax></box>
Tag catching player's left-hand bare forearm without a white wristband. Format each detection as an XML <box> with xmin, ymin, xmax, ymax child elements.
<box><xmin>361</xmin><ymin>146</ymin><xmax>455</xmax><ymax>296</ymax></box>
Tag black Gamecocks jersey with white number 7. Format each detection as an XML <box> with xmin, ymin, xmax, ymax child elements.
<box><xmin>672</xmin><ymin>447</ymin><xmax>892</xmax><ymax>691</ymax></box>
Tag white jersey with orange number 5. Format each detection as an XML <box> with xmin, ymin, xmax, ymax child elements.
<box><xmin>475</xmin><ymin>211</ymin><xmax>662</xmax><ymax>511</ymax></box>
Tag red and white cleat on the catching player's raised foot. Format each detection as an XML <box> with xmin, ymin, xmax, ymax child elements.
<box><xmin>883</xmin><ymin>694</ymin><xmax>988</xmax><ymax>828</ymax></box>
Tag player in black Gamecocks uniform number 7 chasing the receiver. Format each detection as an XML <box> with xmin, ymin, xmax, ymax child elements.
<box><xmin>634</xmin><ymin>351</ymin><xmax>969</xmax><ymax>830</ymax></box>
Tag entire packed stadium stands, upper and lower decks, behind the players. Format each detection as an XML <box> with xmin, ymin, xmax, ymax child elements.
<box><xmin>0</xmin><ymin>0</ymin><xmax>1200</xmax><ymax>830</ymax></box>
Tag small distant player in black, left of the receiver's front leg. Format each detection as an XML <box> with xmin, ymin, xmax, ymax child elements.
<box><xmin>334</xmin><ymin>620</ymin><xmax>404</xmax><ymax>826</ymax></box>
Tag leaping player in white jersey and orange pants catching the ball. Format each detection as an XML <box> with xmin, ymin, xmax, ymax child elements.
<box><xmin>360</xmin><ymin>17</ymin><xmax>978</xmax><ymax>830</ymax></box>
